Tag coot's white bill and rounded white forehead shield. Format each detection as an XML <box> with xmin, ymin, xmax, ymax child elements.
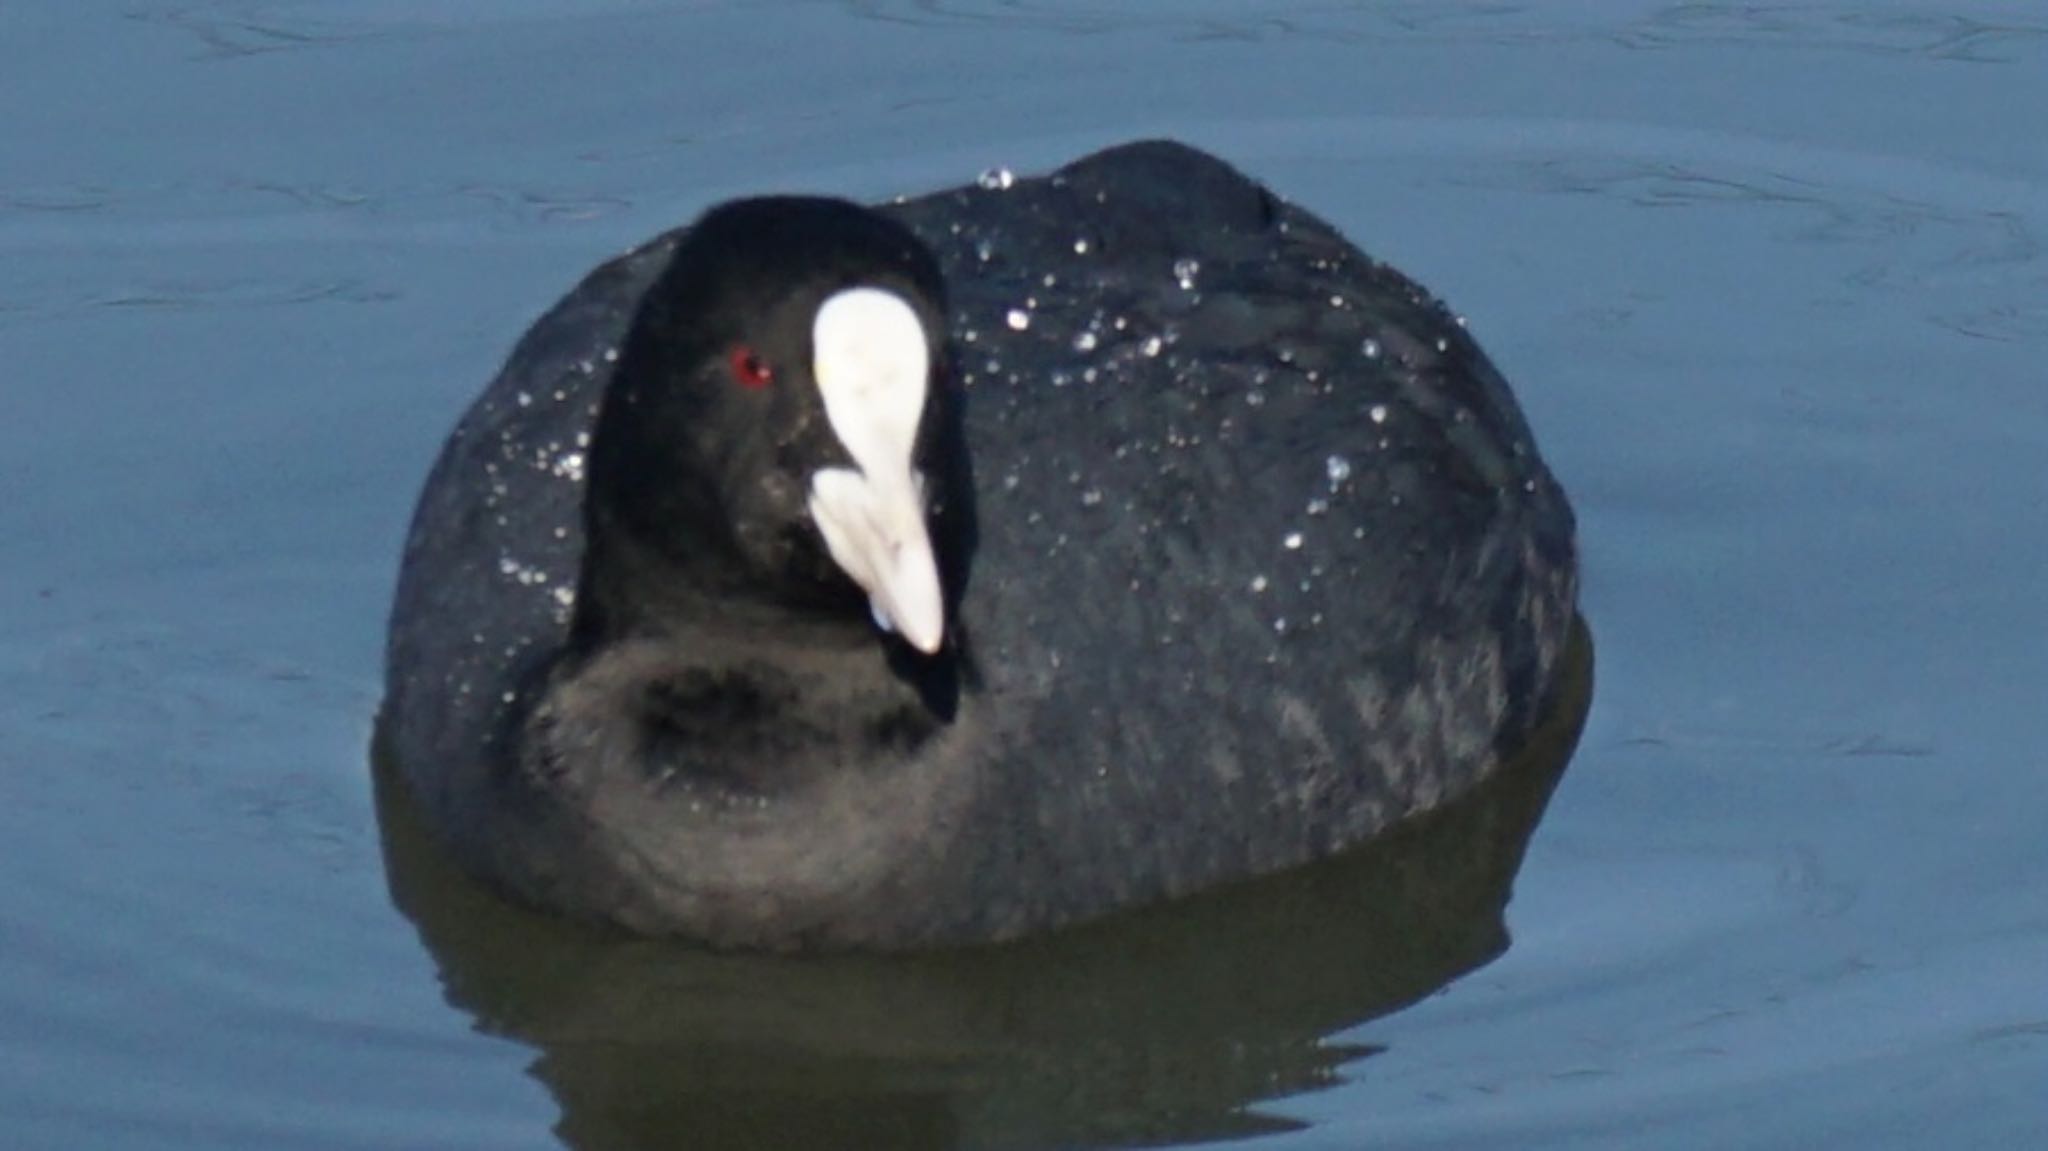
<box><xmin>811</xmin><ymin>287</ymin><xmax>946</xmax><ymax>653</ymax></box>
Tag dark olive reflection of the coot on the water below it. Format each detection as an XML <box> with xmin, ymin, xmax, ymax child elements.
<box><xmin>377</xmin><ymin>627</ymin><xmax>1591</xmax><ymax>1151</ymax></box>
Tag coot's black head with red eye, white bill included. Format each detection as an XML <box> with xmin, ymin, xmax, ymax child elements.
<box><xmin>578</xmin><ymin>197</ymin><xmax>965</xmax><ymax>649</ymax></box>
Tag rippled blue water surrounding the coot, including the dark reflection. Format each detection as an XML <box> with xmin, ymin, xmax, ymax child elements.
<box><xmin>0</xmin><ymin>0</ymin><xmax>2048</xmax><ymax>1149</ymax></box>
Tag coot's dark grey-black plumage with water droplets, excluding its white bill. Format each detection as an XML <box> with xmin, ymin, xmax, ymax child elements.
<box><xmin>381</xmin><ymin>143</ymin><xmax>1575</xmax><ymax>948</ymax></box>
